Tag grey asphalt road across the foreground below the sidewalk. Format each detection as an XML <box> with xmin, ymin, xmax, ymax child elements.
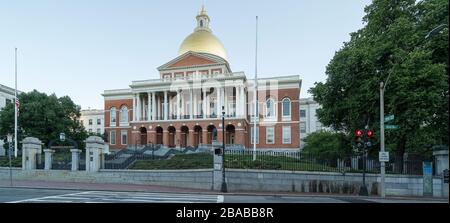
<box><xmin>0</xmin><ymin>187</ymin><xmax>448</xmax><ymax>203</ymax></box>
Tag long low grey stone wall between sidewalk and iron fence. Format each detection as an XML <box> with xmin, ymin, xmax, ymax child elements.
<box><xmin>0</xmin><ymin>167</ymin><xmax>448</xmax><ymax>197</ymax></box>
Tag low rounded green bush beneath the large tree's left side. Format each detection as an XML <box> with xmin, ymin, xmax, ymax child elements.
<box><xmin>304</xmin><ymin>131</ymin><xmax>352</xmax><ymax>159</ymax></box>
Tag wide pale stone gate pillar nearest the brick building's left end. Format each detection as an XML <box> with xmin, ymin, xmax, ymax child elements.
<box><xmin>84</xmin><ymin>136</ymin><xmax>106</xmax><ymax>172</ymax></box>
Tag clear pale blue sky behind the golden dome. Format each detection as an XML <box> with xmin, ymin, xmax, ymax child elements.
<box><xmin>0</xmin><ymin>0</ymin><xmax>370</xmax><ymax>109</ymax></box>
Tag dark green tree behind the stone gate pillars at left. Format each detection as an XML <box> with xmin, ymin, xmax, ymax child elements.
<box><xmin>0</xmin><ymin>90</ymin><xmax>87</xmax><ymax>148</ymax></box>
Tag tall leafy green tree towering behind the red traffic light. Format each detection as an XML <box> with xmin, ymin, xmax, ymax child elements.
<box><xmin>310</xmin><ymin>0</ymin><xmax>449</xmax><ymax>172</ymax></box>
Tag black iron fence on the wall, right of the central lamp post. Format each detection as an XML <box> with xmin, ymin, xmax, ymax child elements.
<box><xmin>225</xmin><ymin>150</ymin><xmax>429</xmax><ymax>175</ymax></box>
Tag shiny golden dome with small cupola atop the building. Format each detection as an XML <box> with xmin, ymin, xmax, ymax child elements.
<box><xmin>178</xmin><ymin>7</ymin><xmax>228</xmax><ymax>60</ymax></box>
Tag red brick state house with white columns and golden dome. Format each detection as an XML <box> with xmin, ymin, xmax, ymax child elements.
<box><xmin>103</xmin><ymin>8</ymin><xmax>301</xmax><ymax>150</ymax></box>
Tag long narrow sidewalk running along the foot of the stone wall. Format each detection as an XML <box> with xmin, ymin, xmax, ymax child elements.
<box><xmin>0</xmin><ymin>180</ymin><xmax>448</xmax><ymax>202</ymax></box>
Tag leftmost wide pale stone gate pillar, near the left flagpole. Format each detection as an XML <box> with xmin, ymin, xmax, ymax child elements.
<box><xmin>21</xmin><ymin>137</ymin><xmax>43</xmax><ymax>170</ymax></box>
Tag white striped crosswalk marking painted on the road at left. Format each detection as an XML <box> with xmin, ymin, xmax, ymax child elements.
<box><xmin>10</xmin><ymin>191</ymin><xmax>224</xmax><ymax>203</ymax></box>
